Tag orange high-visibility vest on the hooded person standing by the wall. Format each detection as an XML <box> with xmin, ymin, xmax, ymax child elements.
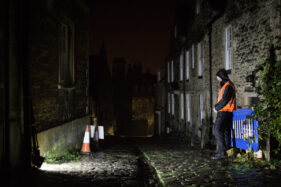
<box><xmin>217</xmin><ymin>81</ymin><xmax>236</xmax><ymax>112</ymax></box>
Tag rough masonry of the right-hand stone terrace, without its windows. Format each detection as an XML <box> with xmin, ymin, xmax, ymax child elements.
<box><xmin>165</xmin><ymin>0</ymin><xmax>280</xmax><ymax>145</ymax></box>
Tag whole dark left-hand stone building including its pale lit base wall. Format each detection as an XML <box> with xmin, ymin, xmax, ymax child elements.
<box><xmin>0</xmin><ymin>0</ymin><xmax>90</xmax><ymax>170</ymax></box>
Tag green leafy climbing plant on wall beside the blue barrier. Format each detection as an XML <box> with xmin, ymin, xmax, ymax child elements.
<box><xmin>250</xmin><ymin>47</ymin><xmax>281</xmax><ymax>149</ymax></box>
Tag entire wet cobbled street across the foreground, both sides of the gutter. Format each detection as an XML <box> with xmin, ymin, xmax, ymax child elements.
<box><xmin>8</xmin><ymin>138</ymin><xmax>281</xmax><ymax>187</ymax></box>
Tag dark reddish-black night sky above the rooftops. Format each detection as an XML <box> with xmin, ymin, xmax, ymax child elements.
<box><xmin>90</xmin><ymin>0</ymin><xmax>188</xmax><ymax>73</ymax></box>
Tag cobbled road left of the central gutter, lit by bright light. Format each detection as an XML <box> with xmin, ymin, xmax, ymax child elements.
<box><xmin>28</xmin><ymin>140</ymin><xmax>143</xmax><ymax>186</ymax></box>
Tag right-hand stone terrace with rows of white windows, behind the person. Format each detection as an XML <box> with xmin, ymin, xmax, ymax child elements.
<box><xmin>166</xmin><ymin>0</ymin><xmax>280</xmax><ymax>146</ymax></box>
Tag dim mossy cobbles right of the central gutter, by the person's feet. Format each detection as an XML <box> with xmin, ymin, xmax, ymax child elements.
<box><xmin>139</xmin><ymin>137</ymin><xmax>281</xmax><ymax>186</ymax></box>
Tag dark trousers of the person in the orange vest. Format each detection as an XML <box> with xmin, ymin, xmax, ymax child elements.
<box><xmin>214</xmin><ymin>112</ymin><xmax>233</xmax><ymax>154</ymax></box>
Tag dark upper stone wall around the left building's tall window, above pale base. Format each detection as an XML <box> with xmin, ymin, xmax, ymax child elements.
<box><xmin>29</xmin><ymin>0</ymin><xmax>89</xmax><ymax>131</ymax></box>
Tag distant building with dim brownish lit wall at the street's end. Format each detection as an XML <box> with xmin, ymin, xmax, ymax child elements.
<box><xmin>127</xmin><ymin>63</ymin><xmax>155</xmax><ymax>136</ymax></box>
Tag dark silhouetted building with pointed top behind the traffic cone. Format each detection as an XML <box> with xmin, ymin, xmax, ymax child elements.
<box><xmin>89</xmin><ymin>45</ymin><xmax>116</xmax><ymax>135</ymax></box>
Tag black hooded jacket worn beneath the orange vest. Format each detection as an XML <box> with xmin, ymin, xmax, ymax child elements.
<box><xmin>215</xmin><ymin>69</ymin><xmax>235</xmax><ymax>111</ymax></box>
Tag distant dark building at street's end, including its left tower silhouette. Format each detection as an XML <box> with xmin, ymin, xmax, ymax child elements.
<box><xmin>112</xmin><ymin>58</ymin><xmax>155</xmax><ymax>136</ymax></box>
